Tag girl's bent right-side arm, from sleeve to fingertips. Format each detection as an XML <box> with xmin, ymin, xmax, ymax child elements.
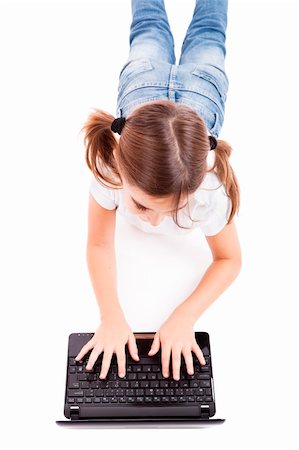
<box><xmin>148</xmin><ymin>223</ymin><xmax>241</xmax><ymax>380</ymax></box>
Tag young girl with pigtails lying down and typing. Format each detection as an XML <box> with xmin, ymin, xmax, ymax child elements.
<box><xmin>76</xmin><ymin>0</ymin><xmax>241</xmax><ymax>380</ymax></box>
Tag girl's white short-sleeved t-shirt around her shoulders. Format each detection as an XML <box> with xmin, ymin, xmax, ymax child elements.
<box><xmin>89</xmin><ymin>172</ymin><xmax>231</xmax><ymax>236</ymax></box>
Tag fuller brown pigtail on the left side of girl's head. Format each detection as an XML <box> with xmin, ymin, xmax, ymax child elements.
<box><xmin>81</xmin><ymin>109</ymin><xmax>119</xmax><ymax>187</ymax></box>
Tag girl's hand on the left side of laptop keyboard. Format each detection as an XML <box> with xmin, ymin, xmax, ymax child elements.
<box><xmin>75</xmin><ymin>316</ymin><xmax>139</xmax><ymax>378</ymax></box>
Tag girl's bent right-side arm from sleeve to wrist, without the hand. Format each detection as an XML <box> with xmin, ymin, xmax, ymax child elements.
<box><xmin>175</xmin><ymin>222</ymin><xmax>242</xmax><ymax>324</ymax></box>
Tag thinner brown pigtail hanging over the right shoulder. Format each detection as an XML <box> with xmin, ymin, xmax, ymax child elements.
<box><xmin>209</xmin><ymin>139</ymin><xmax>240</xmax><ymax>223</ymax></box>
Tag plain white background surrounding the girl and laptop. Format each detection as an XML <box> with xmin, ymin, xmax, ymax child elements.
<box><xmin>0</xmin><ymin>0</ymin><xmax>299</xmax><ymax>450</ymax></box>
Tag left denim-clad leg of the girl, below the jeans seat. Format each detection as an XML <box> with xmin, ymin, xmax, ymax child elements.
<box><xmin>128</xmin><ymin>0</ymin><xmax>175</xmax><ymax>64</ymax></box>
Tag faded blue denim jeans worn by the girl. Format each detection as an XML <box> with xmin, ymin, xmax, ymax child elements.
<box><xmin>116</xmin><ymin>0</ymin><xmax>229</xmax><ymax>137</ymax></box>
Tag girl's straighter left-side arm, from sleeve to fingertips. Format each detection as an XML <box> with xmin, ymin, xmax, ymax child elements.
<box><xmin>75</xmin><ymin>195</ymin><xmax>139</xmax><ymax>378</ymax></box>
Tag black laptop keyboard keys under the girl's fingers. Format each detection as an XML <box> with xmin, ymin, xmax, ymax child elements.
<box><xmin>66</xmin><ymin>352</ymin><xmax>214</xmax><ymax>407</ymax></box>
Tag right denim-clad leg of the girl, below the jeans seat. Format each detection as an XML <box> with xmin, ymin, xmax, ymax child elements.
<box><xmin>179</xmin><ymin>0</ymin><xmax>228</xmax><ymax>72</ymax></box>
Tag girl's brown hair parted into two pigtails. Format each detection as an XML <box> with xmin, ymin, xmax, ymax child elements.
<box><xmin>81</xmin><ymin>100</ymin><xmax>240</xmax><ymax>228</ymax></box>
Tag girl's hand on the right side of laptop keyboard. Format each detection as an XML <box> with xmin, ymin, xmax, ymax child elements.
<box><xmin>148</xmin><ymin>308</ymin><xmax>206</xmax><ymax>380</ymax></box>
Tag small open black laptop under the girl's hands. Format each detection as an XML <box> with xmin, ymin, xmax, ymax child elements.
<box><xmin>56</xmin><ymin>331</ymin><xmax>225</xmax><ymax>428</ymax></box>
